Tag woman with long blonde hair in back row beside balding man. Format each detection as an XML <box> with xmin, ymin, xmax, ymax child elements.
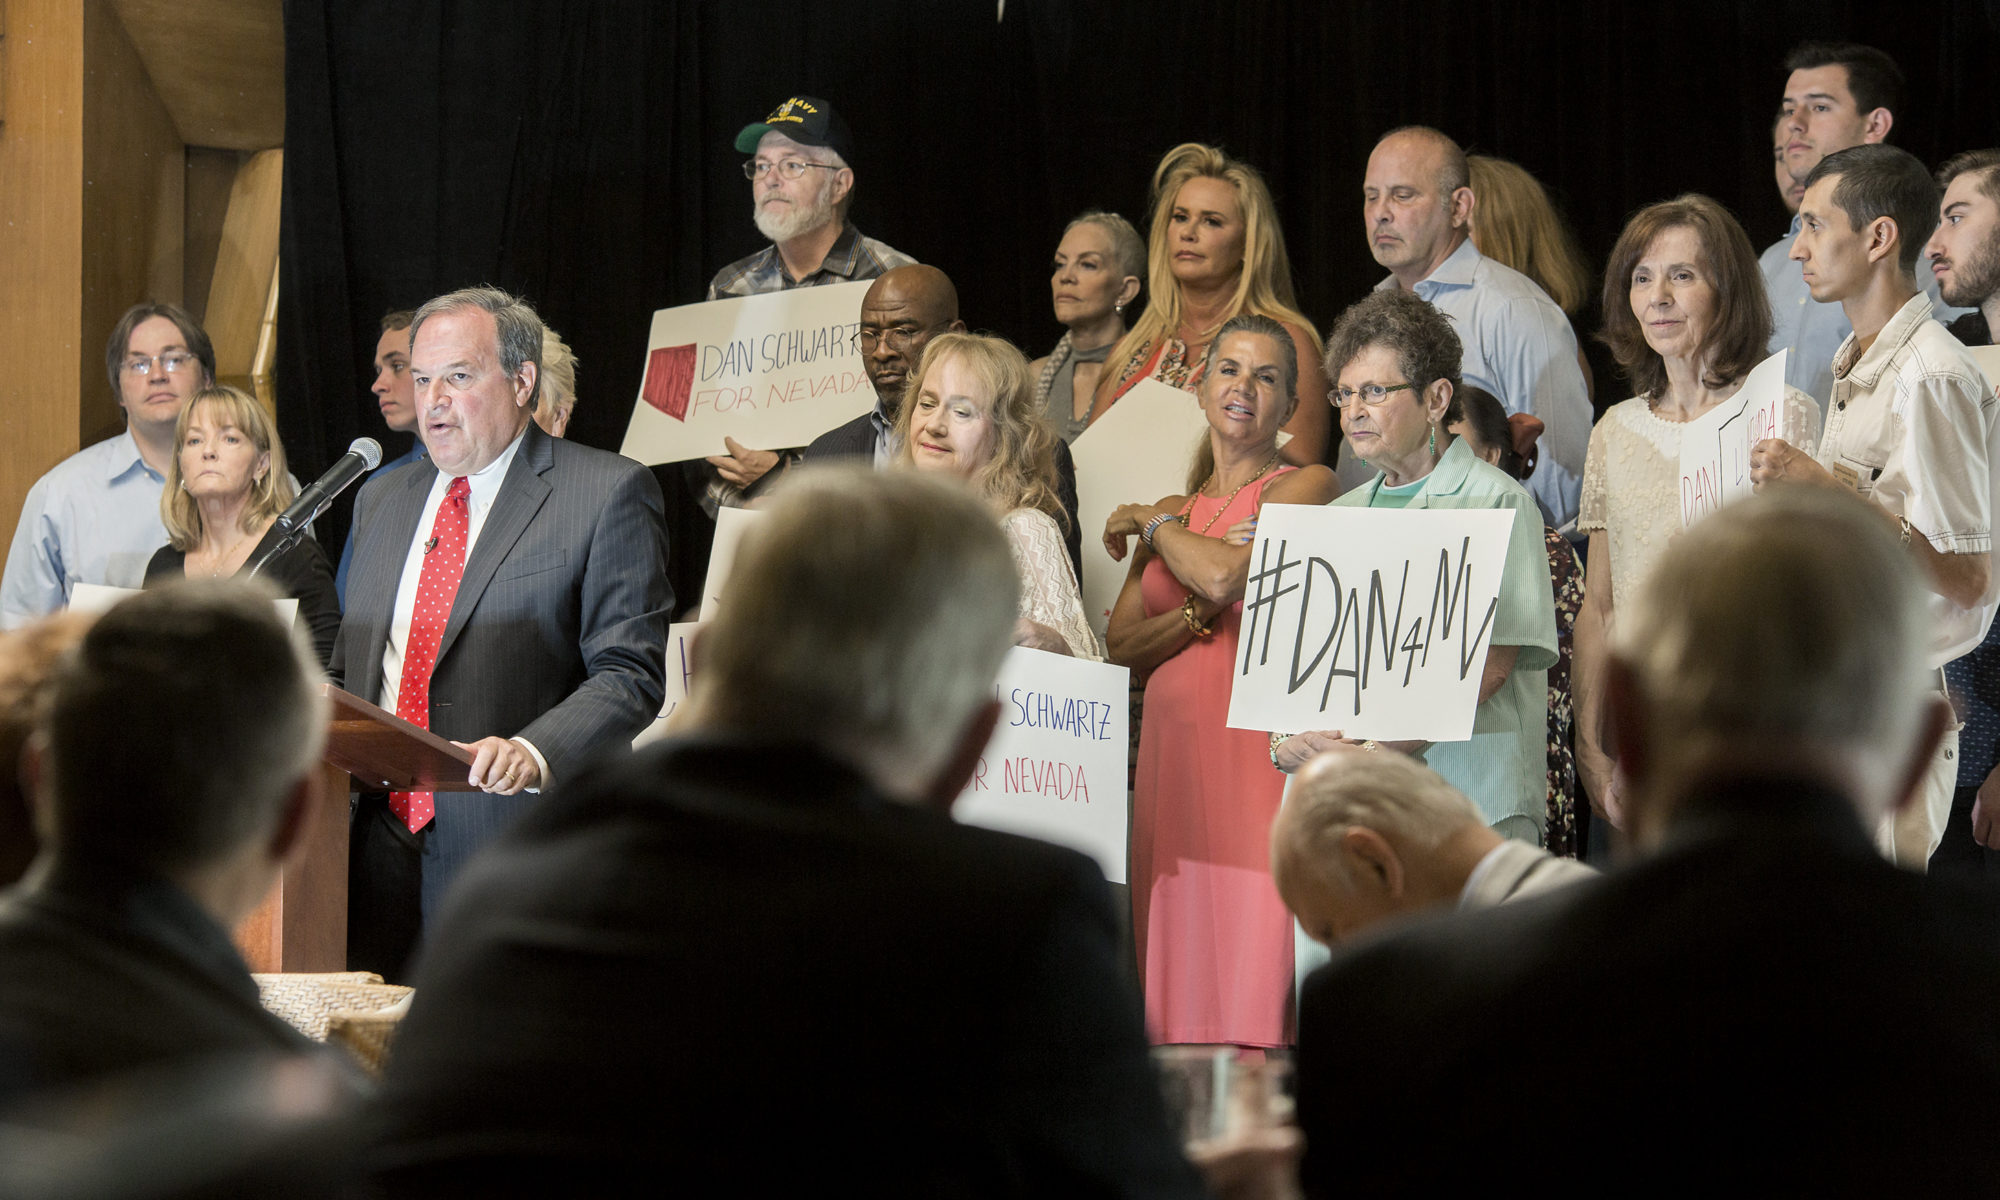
<box><xmin>1092</xmin><ymin>142</ymin><xmax>1332</xmax><ymax>466</ymax></box>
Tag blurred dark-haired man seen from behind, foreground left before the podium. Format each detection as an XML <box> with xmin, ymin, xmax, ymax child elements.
<box><xmin>0</xmin><ymin>580</ymin><xmax>326</xmax><ymax>1106</ymax></box>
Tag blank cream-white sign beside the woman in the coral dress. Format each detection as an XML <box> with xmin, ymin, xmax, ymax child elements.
<box><xmin>1070</xmin><ymin>380</ymin><xmax>1208</xmax><ymax>640</ymax></box>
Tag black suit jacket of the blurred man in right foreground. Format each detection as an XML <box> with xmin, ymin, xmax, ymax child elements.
<box><xmin>1298</xmin><ymin>784</ymin><xmax>2000</xmax><ymax>1196</ymax></box>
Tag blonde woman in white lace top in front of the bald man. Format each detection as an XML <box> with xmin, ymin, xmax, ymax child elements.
<box><xmin>896</xmin><ymin>334</ymin><xmax>1104</xmax><ymax>660</ymax></box>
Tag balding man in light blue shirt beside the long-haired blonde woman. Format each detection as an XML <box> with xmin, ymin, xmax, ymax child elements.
<box><xmin>1340</xmin><ymin>126</ymin><xmax>1590</xmax><ymax>528</ymax></box>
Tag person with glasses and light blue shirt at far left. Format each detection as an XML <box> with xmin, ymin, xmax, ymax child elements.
<box><xmin>0</xmin><ymin>304</ymin><xmax>216</xmax><ymax>630</ymax></box>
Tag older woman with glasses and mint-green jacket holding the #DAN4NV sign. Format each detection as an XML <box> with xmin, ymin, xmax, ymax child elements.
<box><xmin>1270</xmin><ymin>288</ymin><xmax>1556</xmax><ymax>844</ymax></box>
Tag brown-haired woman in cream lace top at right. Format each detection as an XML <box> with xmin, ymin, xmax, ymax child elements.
<box><xmin>1574</xmin><ymin>194</ymin><xmax>1820</xmax><ymax>824</ymax></box>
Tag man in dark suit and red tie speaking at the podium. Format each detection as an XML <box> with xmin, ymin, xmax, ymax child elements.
<box><xmin>330</xmin><ymin>288</ymin><xmax>672</xmax><ymax>978</ymax></box>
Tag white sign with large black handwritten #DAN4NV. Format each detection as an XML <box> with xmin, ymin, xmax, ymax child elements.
<box><xmin>1230</xmin><ymin>504</ymin><xmax>1514</xmax><ymax>742</ymax></box>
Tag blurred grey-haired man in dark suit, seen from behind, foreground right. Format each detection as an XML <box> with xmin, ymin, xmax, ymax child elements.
<box><xmin>1298</xmin><ymin>486</ymin><xmax>2000</xmax><ymax>1196</ymax></box>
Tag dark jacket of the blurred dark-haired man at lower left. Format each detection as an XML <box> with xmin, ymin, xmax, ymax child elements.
<box><xmin>0</xmin><ymin>864</ymin><xmax>314</xmax><ymax>1108</ymax></box>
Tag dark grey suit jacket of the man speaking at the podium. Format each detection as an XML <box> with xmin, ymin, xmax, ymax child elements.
<box><xmin>330</xmin><ymin>422</ymin><xmax>674</xmax><ymax>892</ymax></box>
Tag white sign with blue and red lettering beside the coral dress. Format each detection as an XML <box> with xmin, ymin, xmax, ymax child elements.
<box><xmin>952</xmin><ymin>646</ymin><xmax>1132</xmax><ymax>884</ymax></box>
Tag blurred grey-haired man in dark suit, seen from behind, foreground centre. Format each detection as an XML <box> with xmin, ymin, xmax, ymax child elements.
<box><xmin>380</xmin><ymin>468</ymin><xmax>1200</xmax><ymax>1196</ymax></box>
